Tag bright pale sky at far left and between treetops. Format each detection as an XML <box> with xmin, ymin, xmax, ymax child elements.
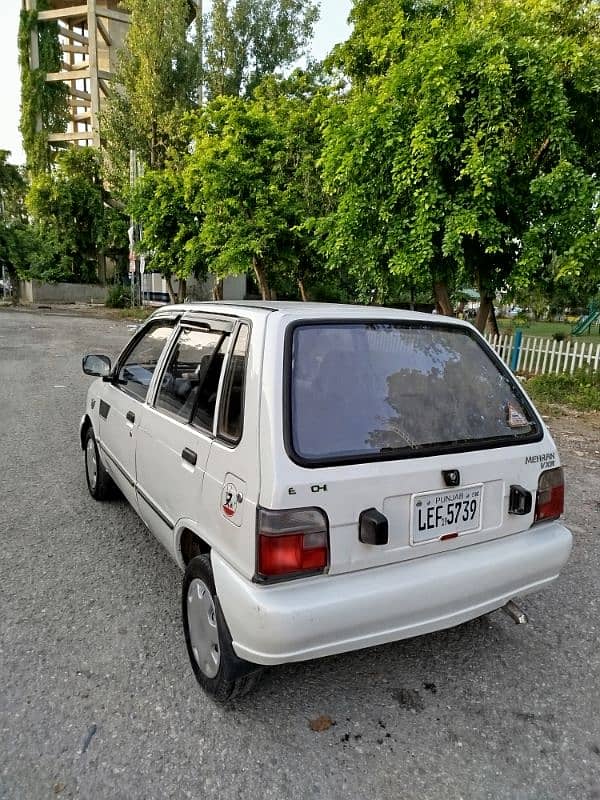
<box><xmin>0</xmin><ymin>0</ymin><xmax>352</xmax><ymax>164</ymax></box>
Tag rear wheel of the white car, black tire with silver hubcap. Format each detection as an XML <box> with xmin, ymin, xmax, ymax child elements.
<box><xmin>181</xmin><ymin>554</ymin><xmax>262</xmax><ymax>703</ymax></box>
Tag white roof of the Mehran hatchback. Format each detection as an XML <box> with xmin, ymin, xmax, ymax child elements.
<box><xmin>155</xmin><ymin>300</ymin><xmax>473</xmax><ymax>328</ymax></box>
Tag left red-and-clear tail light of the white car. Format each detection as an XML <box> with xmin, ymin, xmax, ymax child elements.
<box><xmin>256</xmin><ymin>508</ymin><xmax>329</xmax><ymax>580</ymax></box>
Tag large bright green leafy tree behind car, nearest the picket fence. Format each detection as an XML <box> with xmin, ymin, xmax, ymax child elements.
<box><xmin>322</xmin><ymin>0</ymin><xmax>600</xmax><ymax>329</ymax></box>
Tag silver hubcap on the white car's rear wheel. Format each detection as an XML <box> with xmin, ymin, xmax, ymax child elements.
<box><xmin>187</xmin><ymin>578</ymin><xmax>221</xmax><ymax>678</ymax></box>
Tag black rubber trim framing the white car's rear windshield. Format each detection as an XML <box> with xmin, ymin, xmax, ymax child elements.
<box><xmin>282</xmin><ymin>317</ymin><xmax>544</xmax><ymax>469</ymax></box>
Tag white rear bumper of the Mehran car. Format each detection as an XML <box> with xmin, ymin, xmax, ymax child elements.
<box><xmin>212</xmin><ymin>522</ymin><xmax>572</xmax><ymax>664</ymax></box>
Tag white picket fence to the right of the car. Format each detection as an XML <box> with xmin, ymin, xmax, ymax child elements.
<box><xmin>485</xmin><ymin>334</ymin><xmax>600</xmax><ymax>375</ymax></box>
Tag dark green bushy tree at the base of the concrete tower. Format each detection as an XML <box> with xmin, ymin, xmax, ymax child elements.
<box><xmin>26</xmin><ymin>147</ymin><xmax>126</xmax><ymax>282</ymax></box>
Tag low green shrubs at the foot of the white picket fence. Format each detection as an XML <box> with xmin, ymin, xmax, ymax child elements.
<box><xmin>526</xmin><ymin>369</ymin><xmax>600</xmax><ymax>411</ymax></box>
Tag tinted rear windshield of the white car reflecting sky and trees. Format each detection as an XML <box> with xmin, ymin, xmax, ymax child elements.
<box><xmin>288</xmin><ymin>323</ymin><xmax>541</xmax><ymax>464</ymax></box>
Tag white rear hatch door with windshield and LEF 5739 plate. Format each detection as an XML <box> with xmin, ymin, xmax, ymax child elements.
<box><xmin>287</xmin><ymin>322</ymin><xmax>558</xmax><ymax>573</ymax></box>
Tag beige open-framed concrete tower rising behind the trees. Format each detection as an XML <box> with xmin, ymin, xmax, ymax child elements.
<box><xmin>22</xmin><ymin>0</ymin><xmax>129</xmax><ymax>148</ymax></box>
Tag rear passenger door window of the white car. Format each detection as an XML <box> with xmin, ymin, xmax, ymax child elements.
<box><xmin>155</xmin><ymin>328</ymin><xmax>225</xmax><ymax>428</ymax></box>
